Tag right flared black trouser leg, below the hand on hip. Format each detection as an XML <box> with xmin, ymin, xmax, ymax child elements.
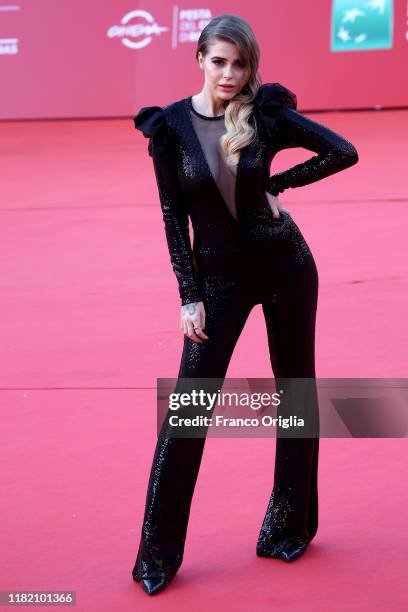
<box><xmin>257</xmin><ymin>249</ymin><xmax>319</xmax><ymax>556</ymax></box>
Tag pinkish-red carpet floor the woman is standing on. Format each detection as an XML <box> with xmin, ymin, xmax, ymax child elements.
<box><xmin>0</xmin><ymin>111</ymin><xmax>408</xmax><ymax>612</ymax></box>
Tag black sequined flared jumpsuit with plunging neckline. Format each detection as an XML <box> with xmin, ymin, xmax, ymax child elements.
<box><xmin>132</xmin><ymin>83</ymin><xmax>358</xmax><ymax>581</ymax></box>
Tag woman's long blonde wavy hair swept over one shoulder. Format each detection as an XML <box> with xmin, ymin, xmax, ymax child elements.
<box><xmin>196</xmin><ymin>13</ymin><xmax>262</xmax><ymax>174</ymax></box>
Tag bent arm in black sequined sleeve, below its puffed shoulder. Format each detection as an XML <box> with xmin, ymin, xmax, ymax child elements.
<box><xmin>265</xmin><ymin>105</ymin><xmax>358</xmax><ymax>196</ymax></box>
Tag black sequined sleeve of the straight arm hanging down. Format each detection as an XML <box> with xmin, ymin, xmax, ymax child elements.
<box><xmin>134</xmin><ymin>106</ymin><xmax>202</xmax><ymax>305</ymax></box>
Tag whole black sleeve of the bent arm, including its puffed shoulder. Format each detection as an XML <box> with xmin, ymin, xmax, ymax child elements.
<box><xmin>255</xmin><ymin>83</ymin><xmax>359</xmax><ymax>196</ymax></box>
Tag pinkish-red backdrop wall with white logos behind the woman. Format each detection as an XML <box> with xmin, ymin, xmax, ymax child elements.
<box><xmin>0</xmin><ymin>0</ymin><xmax>408</xmax><ymax>119</ymax></box>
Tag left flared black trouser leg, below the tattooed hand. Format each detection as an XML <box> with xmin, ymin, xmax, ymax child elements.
<box><xmin>132</xmin><ymin>277</ymin><xmax>254</xmax><ymax>581</ymax></box>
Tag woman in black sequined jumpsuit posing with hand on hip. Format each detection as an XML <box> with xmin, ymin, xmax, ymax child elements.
<box><xmin>132</xmin><ymin>14</ymin><xmax>358</xmax><ymax>595</ymax></box>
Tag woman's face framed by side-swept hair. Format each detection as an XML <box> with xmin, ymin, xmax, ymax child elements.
<box><xmin>198</xmin><ymin>40</ymin><xmax>247</xmax><ymax>100</ymax></box>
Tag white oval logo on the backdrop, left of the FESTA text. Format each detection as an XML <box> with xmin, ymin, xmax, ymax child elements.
<box><xmin>107</xmin><ymin>10</ymin><xmax>169</xmax><ymax>49</ymax></box>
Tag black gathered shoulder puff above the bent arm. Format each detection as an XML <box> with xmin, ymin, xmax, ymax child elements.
<box><xmin>254</xmin><ymin>83</ymin><xmax>297</xmax><ymax>138</ymax></box>
